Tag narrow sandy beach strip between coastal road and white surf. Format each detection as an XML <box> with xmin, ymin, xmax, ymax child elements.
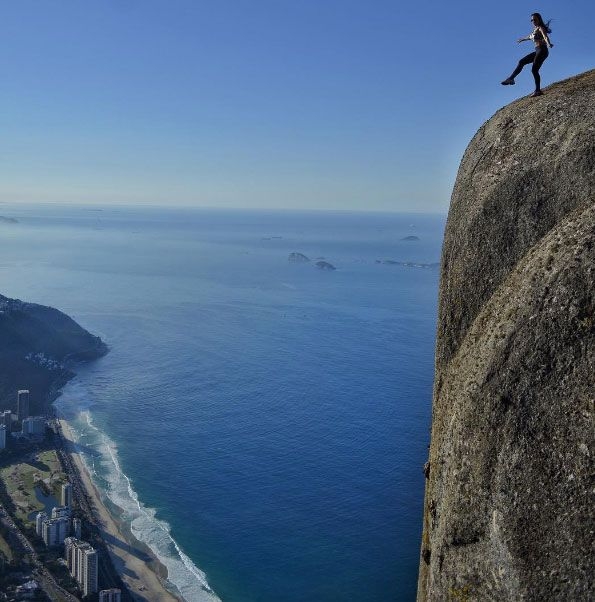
<box><xmin>59</xmin><ymin>419</ymin><xmax>183</xmax><ymax>602</ymax></box>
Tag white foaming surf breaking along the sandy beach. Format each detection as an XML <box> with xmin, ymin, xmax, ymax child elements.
<box><xmin>56</xmin><ymin>379</ymin><xmax>219</xmax><ymax>602</ymax></box>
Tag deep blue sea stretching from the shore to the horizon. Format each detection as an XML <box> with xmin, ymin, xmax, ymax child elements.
<box><xmin>0</xmin><ymin>204</ymin><xmax>444</xmax><ymax>602</ymax></box>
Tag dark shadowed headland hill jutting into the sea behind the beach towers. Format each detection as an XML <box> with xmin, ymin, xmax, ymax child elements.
<box><xmin>0</xmin><ymin>295</ymin><xmax>107</xmax><ymax>414</ymax></box>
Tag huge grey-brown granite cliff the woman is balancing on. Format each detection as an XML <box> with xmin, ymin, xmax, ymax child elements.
<box><xmin>418</xmin><ymin>71</ymin><xmax>595</xmax><ymax>601</ymax></box>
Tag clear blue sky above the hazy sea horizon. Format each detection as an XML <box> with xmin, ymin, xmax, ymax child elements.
<box><xmin>0</xmin><ymin>0</ymin><xmax>595</xmax><ymax>212</ymax></box>
